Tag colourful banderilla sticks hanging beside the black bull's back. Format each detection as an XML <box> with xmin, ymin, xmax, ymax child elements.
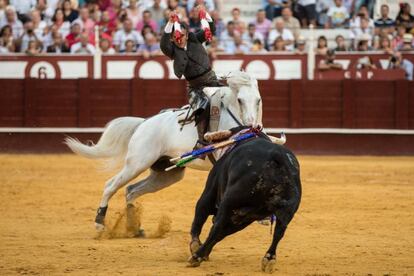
<box><xmin>165</xmin><ymin>132</ymin><xmax>257</xmax><ymax>171</ymax></box>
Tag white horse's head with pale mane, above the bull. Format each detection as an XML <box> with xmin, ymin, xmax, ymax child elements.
<box><xmin>227</xmin><ymin>71</ymin><xmax>263</xmax><ymax>127</ymax></box>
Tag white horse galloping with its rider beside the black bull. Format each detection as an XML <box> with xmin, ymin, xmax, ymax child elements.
<box><xmin>65</xmin><ymin>71</ymin><xmax>274</xmax><ymax>230</ymax></box>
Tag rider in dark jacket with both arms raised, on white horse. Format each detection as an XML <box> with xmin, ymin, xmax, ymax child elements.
<box><xmin>160</xmin><ymin>7</ymin><xmax>220</xmax><ymax>140</ymax></box>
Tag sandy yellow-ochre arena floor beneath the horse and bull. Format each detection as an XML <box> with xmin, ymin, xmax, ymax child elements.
<box><xmin>0</xmin><ymin>155</ymin><xmax>414</xmax><ymax>275</ymax></box>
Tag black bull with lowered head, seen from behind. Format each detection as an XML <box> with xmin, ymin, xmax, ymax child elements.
<box><xmin>189</xmin><ymin>138</ymin><xmax>301</xmax><ymax>272</ymax></box>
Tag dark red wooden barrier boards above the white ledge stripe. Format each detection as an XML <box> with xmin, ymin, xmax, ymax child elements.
<box><xmin>0</xmin><ymin>79</ymin><xmax>414</xmax><ymax>129</ymax></box>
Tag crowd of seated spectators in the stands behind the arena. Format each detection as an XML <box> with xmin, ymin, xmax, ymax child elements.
<box><xmin>0</xmin><ymin>0</ymin><xmax>414</xmax><ymax>57</ymax></box>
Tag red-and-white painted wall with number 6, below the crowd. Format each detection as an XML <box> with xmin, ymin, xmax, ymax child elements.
<box><xmin>0</xmin><ymin>52</ymin><xmax>414</xmax><ymax>80</ymax></box>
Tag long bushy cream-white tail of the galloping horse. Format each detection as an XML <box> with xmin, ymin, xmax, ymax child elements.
<box><xmin>64</xmin><ymin>117</ymin><xmax>145</xmax><ymax>167</ymax></box>
